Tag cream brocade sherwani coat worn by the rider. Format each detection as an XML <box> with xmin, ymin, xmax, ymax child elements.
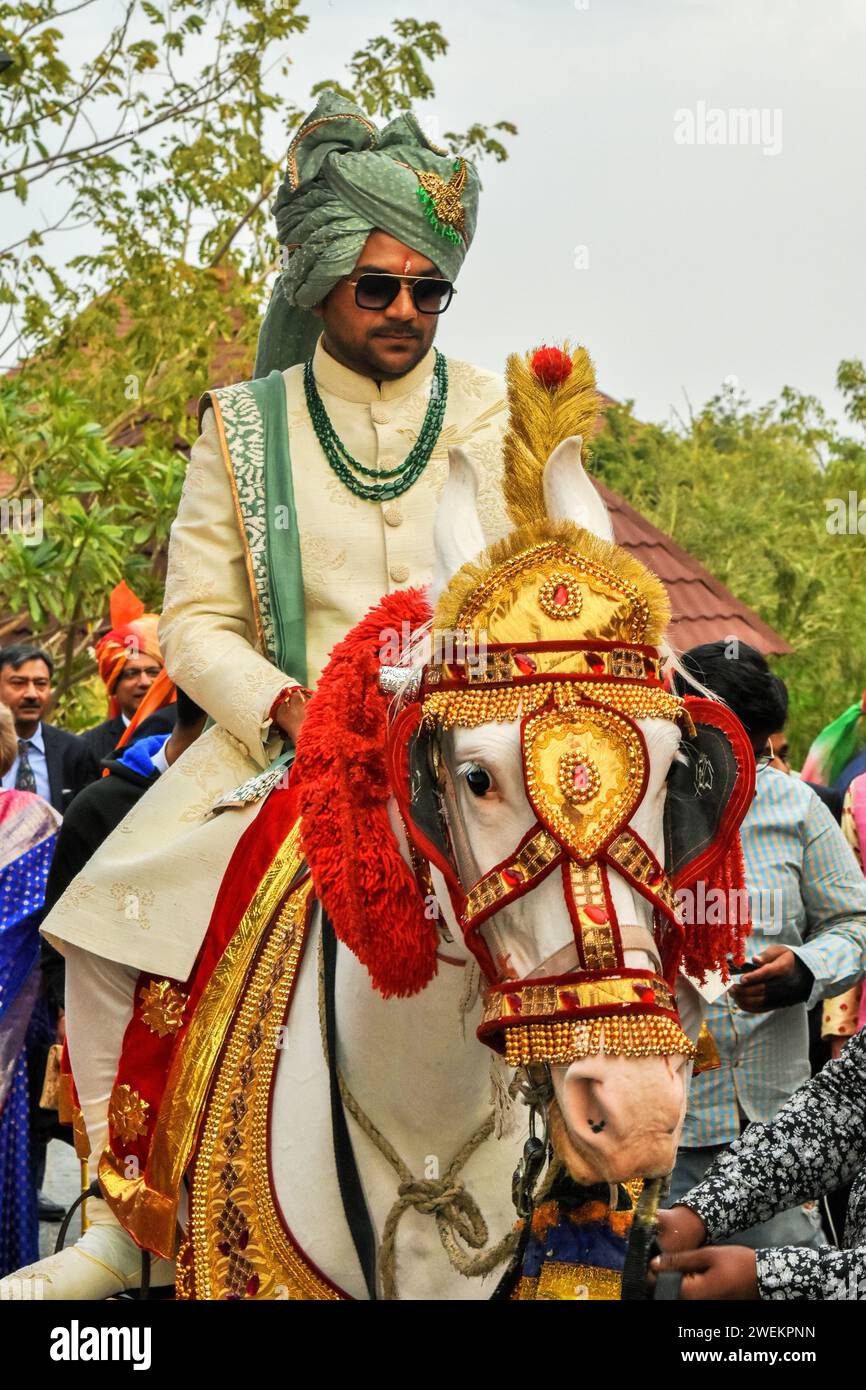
<box><xmin>43</xmin><ymin>343</ymin><xmax>509</xmax><ymax>980</ymax></box>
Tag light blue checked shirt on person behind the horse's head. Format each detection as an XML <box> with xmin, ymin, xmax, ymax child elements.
<box><xmin>680</xmin><ymin>767</ymin><xmax>866</xmax><ymax>1148</ymax></box>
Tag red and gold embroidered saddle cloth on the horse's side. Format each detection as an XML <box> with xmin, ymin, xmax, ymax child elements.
<box><xmin>99</xmin><ymin>790</ymin><xmax>343</xmax><ymax>1298</ymax></box>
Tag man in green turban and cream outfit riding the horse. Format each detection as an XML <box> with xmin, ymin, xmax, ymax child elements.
<box><xmin>3</xmin><ymin>92</ymin><xmax>506</xmax><ymax>1298</ymax></box>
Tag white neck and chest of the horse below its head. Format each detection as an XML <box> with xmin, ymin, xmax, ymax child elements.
<box><xmin>271</xmin><ymin>912</ymin><xmax>524</xmax><ymax>1300</ymax></box>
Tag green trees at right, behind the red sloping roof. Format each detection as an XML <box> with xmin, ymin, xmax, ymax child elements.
<box><xmin>592</xmin><ymin>378</ymin><xmax>866</xmax><ymax>759</ymax></box>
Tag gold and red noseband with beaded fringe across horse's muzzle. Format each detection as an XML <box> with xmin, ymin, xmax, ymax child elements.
<box><xmin>478</xmin><ymin>970</ymin><xmax>695</xmax><ymax>1066</ymax></box>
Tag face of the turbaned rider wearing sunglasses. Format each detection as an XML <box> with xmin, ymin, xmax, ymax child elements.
<box><xmin>314</xmin><ymin>232</ymin><xmax>439</xmax><ymax>381</ymax></box>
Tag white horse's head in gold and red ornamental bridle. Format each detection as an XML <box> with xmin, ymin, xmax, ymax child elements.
<box><xmin>393</xmin><ymin>354</ymin><xmax>750</xmax><ymax>1182</ymax></box>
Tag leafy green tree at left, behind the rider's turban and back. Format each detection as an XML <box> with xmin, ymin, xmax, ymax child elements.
<box><xmin>0</xmin><ymin>8</ymin><xmax>514</xmax><ymax>720</ymax></box>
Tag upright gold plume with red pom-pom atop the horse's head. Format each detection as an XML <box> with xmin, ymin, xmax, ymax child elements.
<box><xmin>502</xmin><ymin>342</ymin><xmax>601</xmax><ymax>525</ymax></box>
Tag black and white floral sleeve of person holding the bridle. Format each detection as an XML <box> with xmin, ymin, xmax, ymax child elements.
<box><xmin>683</xmin><ymin>1030</ymin><xmax>866</xmax><ymax>1300</ymax></box>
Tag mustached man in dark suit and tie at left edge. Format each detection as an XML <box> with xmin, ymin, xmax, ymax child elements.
<box><xmin>0</xmin><ymin>644</ymin><xmax>99</xmax><ymax>813</ymax></box>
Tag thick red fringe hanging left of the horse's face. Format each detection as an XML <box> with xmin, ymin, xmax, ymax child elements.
<box><xmin>292</xmin><ymin>589</ymin><xmax>438</xmax><ymax>998</ymax></box>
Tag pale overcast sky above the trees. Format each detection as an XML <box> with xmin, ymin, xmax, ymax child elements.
<box><xmin>8</xmin><ymin>0</ymin><xmax>866</xmax><ymax>420</ymax></box>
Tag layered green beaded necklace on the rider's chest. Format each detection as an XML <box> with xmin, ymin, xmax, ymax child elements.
<box><xmin>303</xmin><ymin>350</ymin><xmax>448</xmax><ymax>502</ymax></box>
